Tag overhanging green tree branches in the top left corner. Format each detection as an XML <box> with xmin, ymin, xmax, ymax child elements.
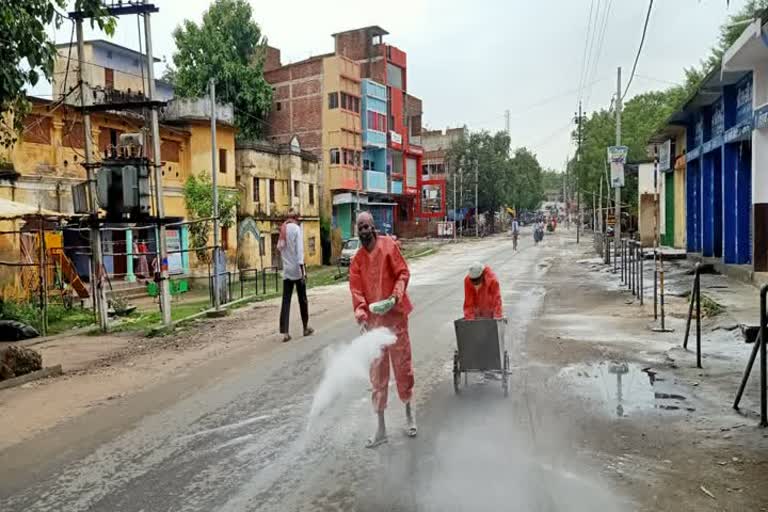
<box><xmin>0</xmin><ymin>0</ymin><xmax>115</xmax><ymax>147</ymax></box>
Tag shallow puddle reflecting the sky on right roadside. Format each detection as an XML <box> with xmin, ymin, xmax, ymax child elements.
<box><xmin>554</xmin><ymin>362</ymin><xmax>696</xmax><ymax>417</ymax></box>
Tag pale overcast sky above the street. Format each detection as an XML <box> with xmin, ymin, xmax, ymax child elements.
<box><xmin>38</xmin><ymin>0</ymin><xmax>745</xmax><ymax>169</ymax></box>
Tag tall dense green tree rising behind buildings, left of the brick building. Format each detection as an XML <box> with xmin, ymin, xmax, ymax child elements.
<box><xmin>169</xmin><ymin>0</ymin><xmax>272</xmax><ymax>139</ymax></box>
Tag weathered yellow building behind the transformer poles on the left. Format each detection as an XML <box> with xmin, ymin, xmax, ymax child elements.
<box><xmin>0</xmin><ymin>93</ymin><xmax>237</xmax><ymax>294</ymax></box>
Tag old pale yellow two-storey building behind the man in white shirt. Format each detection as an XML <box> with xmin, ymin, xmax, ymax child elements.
<box><xmin>236</xmin><ymin>137</ymin><xmax>322</xmax><ymax>269</ymax></box>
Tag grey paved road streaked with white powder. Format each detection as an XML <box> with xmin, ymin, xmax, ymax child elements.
<box><xmin>0</xmin><ymin>230</ymin><xmax>617</xmax><ymax>512</ymax></box>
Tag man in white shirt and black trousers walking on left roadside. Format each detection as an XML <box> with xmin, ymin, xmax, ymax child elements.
<box><xmin>277</xmin><ymin>208</ymin><xmax>315</xmax><ymax>342</ymax></box>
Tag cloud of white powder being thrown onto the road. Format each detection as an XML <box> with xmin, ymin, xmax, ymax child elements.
<box><xmin>309</xmin><ymin>327</ymin><xmax>395</xmax><ymax>426</ymax></box>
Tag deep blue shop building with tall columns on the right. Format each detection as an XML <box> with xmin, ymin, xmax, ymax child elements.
<box><xmin>673</xmin><ymin>69</ymin><xmax>753</xmax><ymax>265</ymax></box>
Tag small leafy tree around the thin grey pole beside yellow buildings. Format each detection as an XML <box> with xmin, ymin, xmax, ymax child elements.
<box><xmin>184</xmin><ymin>172</ymin><xmax>240</xmax><ymax>263</ymax></box>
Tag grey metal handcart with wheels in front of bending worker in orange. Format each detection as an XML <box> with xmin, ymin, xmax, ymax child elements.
<box><xmin>453</xmin><ymin>318</ymin><xmax>510</xmax><ymax>396</ymax></box>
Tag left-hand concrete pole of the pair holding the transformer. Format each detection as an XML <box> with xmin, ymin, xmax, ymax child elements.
<box><xmin>76</xmin><ymin>18</ymin><xmax>109</xmax><ymax>332</ymax></box>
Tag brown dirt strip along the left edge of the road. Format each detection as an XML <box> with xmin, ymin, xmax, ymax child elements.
<box><xmin>0</xmin><ymin>285</ymin><xmax>349</xmax><ymax>450</ymax></box>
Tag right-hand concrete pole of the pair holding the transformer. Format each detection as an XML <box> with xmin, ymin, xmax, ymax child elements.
<box><xmin>144</xmin><ymin>12</ymin><xmax>171</xmax><ymax>326</ymax></box>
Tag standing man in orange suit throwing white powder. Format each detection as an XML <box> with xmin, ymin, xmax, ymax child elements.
<box><xmin>349</xmin><ymin>212</ymin><xmax>417</xmax><ymax>448</ymax></box>
